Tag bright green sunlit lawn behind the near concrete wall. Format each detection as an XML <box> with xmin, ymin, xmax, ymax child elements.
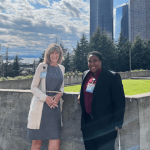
<box><xmin>65</xmin><ymin>79</ymin><xmax>150</xmax><ymax>95</ymax></box>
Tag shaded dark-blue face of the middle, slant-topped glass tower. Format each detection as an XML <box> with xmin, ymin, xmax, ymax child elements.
<box><xmin>121</xmin><ymin>4</ymin><xmax>129</xmax><ymax>40</ymax></box>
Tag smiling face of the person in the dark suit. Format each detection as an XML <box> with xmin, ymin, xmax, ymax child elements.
<box><xmin>88</xmin><ymin>55</ymin><xmax>102</xmax><ymax>73</ymax></box>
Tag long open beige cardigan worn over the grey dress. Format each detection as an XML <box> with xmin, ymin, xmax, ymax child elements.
<box><xmin>27</xmin><ymin>63</ymin><xmax>65</xmax><ymax>129</ymax></box>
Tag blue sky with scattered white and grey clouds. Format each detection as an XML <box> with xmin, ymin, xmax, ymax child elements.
<box><xmin>0</xmin><ymin>0</ymin><xmax>128</xmax><ymax>57</ymax></box>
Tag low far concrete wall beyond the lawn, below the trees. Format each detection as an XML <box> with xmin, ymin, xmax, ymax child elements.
<box><xmin>0</xmin><ymin>70</ymin><xmax>150</xmax><ymax>89</ymax></box>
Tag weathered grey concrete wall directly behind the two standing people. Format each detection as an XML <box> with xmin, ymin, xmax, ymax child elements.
<box><xmin>0</xmin><ymin>89</ymin><xmax>150</xmax><ymax>150</ymax></box>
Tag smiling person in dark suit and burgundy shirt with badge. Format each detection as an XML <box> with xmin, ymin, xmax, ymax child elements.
<box><xmin>78</xmin><ymin>51</ymin><xmax>125</xmax><ymax>150</ymax></box>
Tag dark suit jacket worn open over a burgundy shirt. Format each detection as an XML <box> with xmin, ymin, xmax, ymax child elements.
<box><xmin>80</xmin><ymin>68</ymin><xmax>125</xmax><ymax>131</ymax></box>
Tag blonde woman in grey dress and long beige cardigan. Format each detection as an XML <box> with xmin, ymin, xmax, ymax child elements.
<box><xmin>27</xmin><ymin>44</ymin><xmax>65</xmax><ymax>150</ymax></box>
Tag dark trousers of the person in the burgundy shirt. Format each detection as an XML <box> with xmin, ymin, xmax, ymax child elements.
<box><xmin>82</xmin><ymin>116</ymin><xmax>117</xmax><ymax>150</ymax></box>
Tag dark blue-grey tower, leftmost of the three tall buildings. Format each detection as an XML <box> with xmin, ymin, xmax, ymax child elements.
<box><xmin>90</xmin><ymin>0</ymin><xmax>113</xmax><ymax>39</ymax></box>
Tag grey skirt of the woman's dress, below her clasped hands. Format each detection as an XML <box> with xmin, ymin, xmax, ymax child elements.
<box><xmin>27</xmin><ymin>99</ymin><xmax>61</xmax><ymax>140</ymax></box>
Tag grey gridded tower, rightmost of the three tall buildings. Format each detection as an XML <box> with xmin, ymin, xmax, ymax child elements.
<box><xmin>129</xmin><ymin>0</ymin><xmax>150</xmax><ymax>42</ymax></box>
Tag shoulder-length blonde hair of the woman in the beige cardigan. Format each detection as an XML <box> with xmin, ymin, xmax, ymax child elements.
<box><xmin>43</xmin><ymin>44</ymin><xmax>63</xmax><ymax>64</ymax></box>
